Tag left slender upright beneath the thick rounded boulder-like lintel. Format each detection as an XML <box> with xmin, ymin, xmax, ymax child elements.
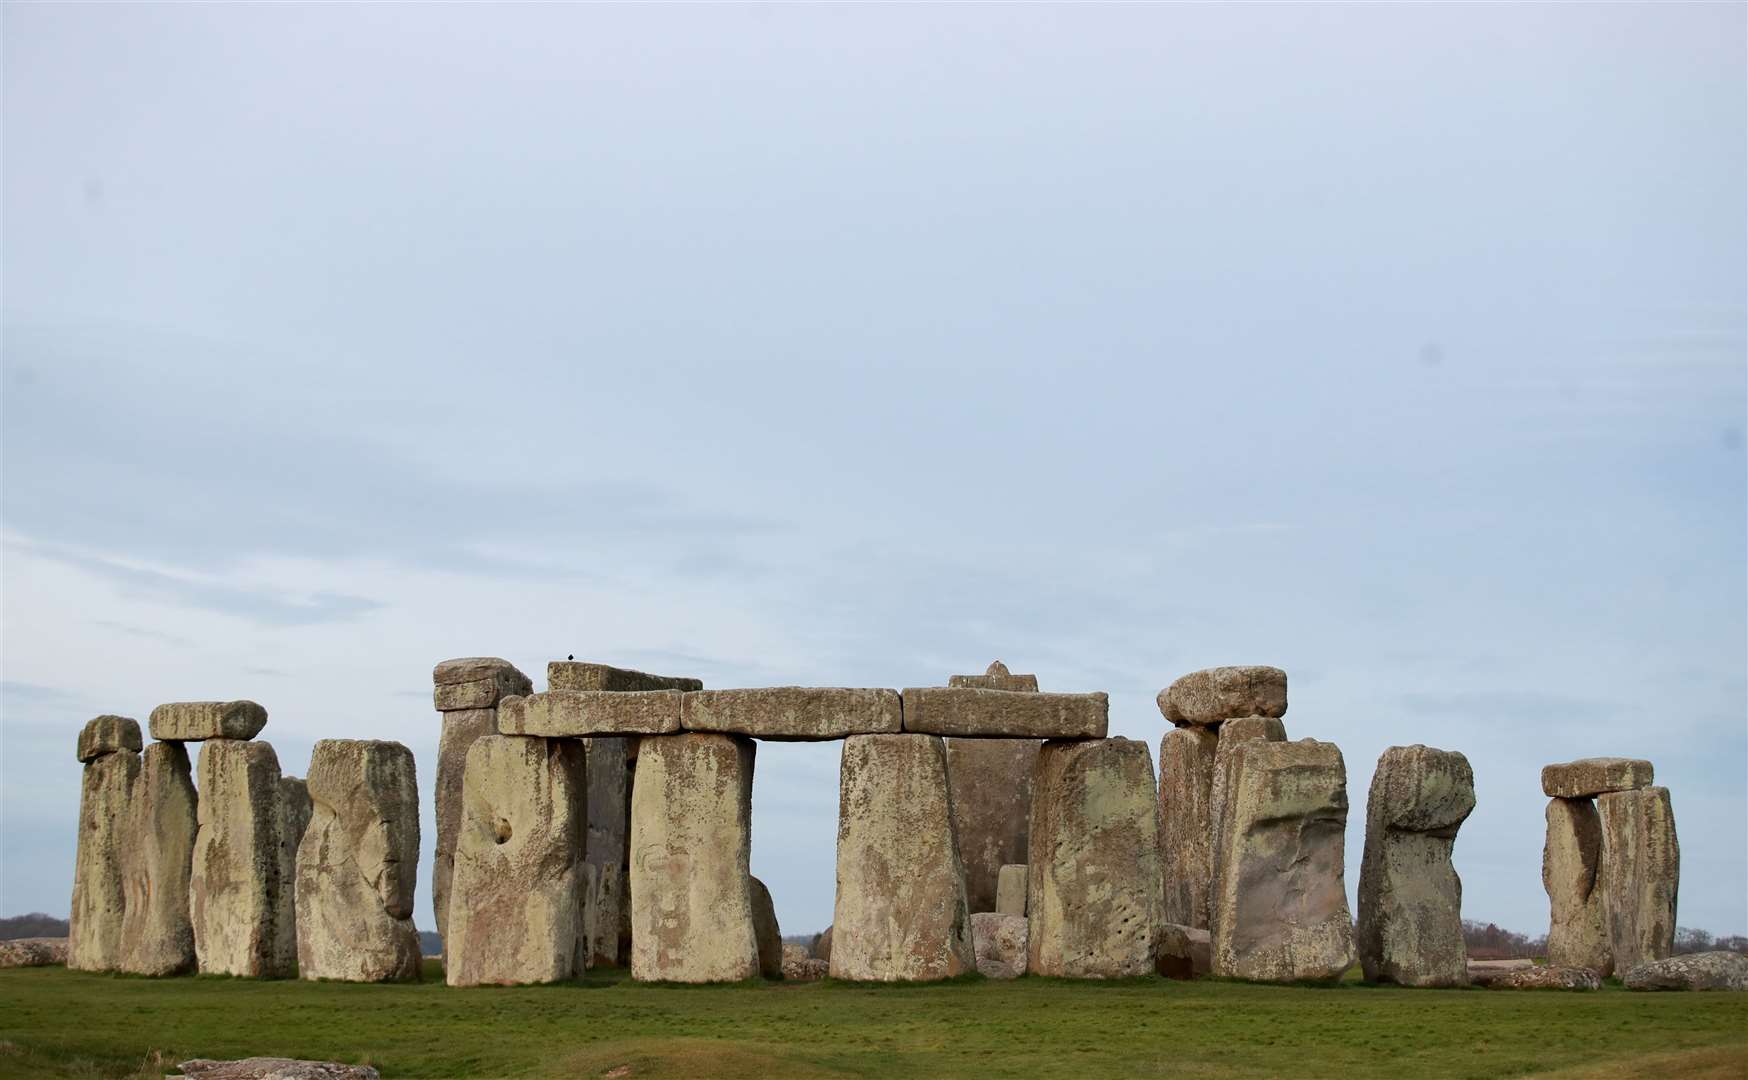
<box><xmin>1159</xmin><ymin>727</ymin><xmax>1220</xmax><ymax>928</ymax></box>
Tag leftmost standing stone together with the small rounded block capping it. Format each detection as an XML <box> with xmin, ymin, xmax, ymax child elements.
<box><xmin>66</xmin><ymin>717</ymin><xmax>140</xmax><ymax>972</ymax></box>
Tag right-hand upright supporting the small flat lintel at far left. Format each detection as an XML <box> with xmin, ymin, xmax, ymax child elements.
<box><xmin>191</xmin><ymin>740</ymin><xmax>297</xmax><ymax>979</ymax></box>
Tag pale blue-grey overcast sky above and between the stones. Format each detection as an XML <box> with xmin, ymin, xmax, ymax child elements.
<box><xmin>0</xmin><ymin>3</ymin><xmax>1748</xmax><ymax>933</ymax></box>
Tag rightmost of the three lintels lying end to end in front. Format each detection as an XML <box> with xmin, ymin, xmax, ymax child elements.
<box><xmin>904</xmin><ymin>687</ymin><xmax>1110</xmax><ymax>739</ymax></box>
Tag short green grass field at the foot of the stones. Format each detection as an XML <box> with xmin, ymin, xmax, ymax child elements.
<box><xmin>0</xmin><ymin>963</ymin><xmax>1748</xmax><ymax>1080</ymax></box>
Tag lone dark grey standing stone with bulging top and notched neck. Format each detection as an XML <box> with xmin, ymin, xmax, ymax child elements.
<box><xmin>1355</xmin><ymin>746</ymin><xmax>1475</xmax><ymax>986</ymax></box>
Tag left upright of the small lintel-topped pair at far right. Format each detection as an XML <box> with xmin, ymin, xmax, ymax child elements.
<box><xmin>1542</xmin><ymin>799</ymin><xmax>1615</xmax><ymax>975</ymax></box>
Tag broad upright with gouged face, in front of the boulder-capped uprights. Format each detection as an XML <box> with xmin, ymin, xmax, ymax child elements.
<box><xmin>1210</xmin><ymin>739</ymin><xmax>1353</xmax><ymax>982</ymax></box>
